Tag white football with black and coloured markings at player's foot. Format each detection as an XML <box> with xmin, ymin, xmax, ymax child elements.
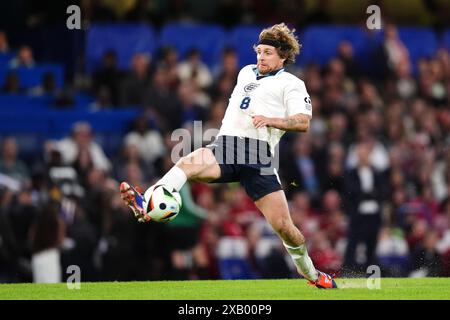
<box><xmin>144</xmin><ymin>185</ymin><xmax>181</xmax><ymax>222</ymax></box>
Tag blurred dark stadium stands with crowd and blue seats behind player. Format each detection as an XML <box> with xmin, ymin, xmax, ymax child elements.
<box><xmin>0</xmin><ymin>0</ymin><xmax>450</xmax><ymax>282</ymax></box>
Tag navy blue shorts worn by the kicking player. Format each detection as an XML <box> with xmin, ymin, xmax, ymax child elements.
<box><xmin>206</xmin><ymin>136</ymin><xmax>282</xmax><ymax>201</ymax></box>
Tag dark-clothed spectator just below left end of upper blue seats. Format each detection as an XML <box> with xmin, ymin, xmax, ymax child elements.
<box><xmin>92</xmin><ymin>50</ymin><xmax>122</xmax><ymax>105</ymax></box>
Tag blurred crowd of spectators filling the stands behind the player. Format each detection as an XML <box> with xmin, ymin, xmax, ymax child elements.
<box><xmin>0</xmin><ymin>21</ymin><xmax>450</xmax><ymax>282</ymax></box>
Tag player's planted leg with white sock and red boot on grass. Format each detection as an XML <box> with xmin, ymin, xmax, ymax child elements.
<box><xmin>255</xmin><ymin>190</ymin><xmax>336</xmax><ymax>288</ymax></box>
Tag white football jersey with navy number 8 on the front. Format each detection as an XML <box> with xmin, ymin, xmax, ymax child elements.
<box><xmin>218</xmin><ymin>64</ymin><xmax>312</xmax><ymax>154</ymax></box>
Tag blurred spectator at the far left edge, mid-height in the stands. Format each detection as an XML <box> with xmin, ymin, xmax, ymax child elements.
<box><xmin>0</xmin><ymin>137</ymin><xmax>31</xmax><ymax>188</ymax></box>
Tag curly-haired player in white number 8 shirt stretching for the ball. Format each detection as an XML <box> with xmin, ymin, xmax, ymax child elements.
<box><xmin>120</xmin><ymin>23</ymin><xmax>336</xmax><ymax>288</ymax></box>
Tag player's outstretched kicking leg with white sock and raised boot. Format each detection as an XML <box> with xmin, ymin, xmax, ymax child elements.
<box><xmin>120</xmin><ymin>148</ymin><xmax>221</xmax><ymax>222</ymax></box>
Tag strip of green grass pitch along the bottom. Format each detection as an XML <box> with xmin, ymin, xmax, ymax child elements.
<box><xmin>0</xmin><ymin>278</ymin><xmax>450</xmax><ymax>300</ymax></box>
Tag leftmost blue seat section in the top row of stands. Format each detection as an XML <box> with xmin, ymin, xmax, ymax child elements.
<box><xmin>85</xmin><ymin>24</ymin><xmax>158</xmax><ymax>73</ymax></box>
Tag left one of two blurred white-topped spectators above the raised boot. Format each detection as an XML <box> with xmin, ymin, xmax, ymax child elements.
<box><xmin>55</xmin><ymin>122</ymin><xmax>111</xmax><ymax>172</ymax></box>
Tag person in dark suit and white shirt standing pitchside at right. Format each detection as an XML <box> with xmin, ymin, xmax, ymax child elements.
<box><xmin>344</xmin><ymin>143</ymin><xmax>385</xmax><ymax>272</ymax></box>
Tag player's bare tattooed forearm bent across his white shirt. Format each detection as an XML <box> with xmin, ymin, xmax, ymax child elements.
<box><xmin>252</xmin><ymin>113</ymin><xmax>311</xmax><ymax>132</ymax></box>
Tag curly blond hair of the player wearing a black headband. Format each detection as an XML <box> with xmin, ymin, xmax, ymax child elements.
<box><xmin>255</xmin><ymin>23</ymin><xmax>302</xmax><ymax>64</ymax></box>
